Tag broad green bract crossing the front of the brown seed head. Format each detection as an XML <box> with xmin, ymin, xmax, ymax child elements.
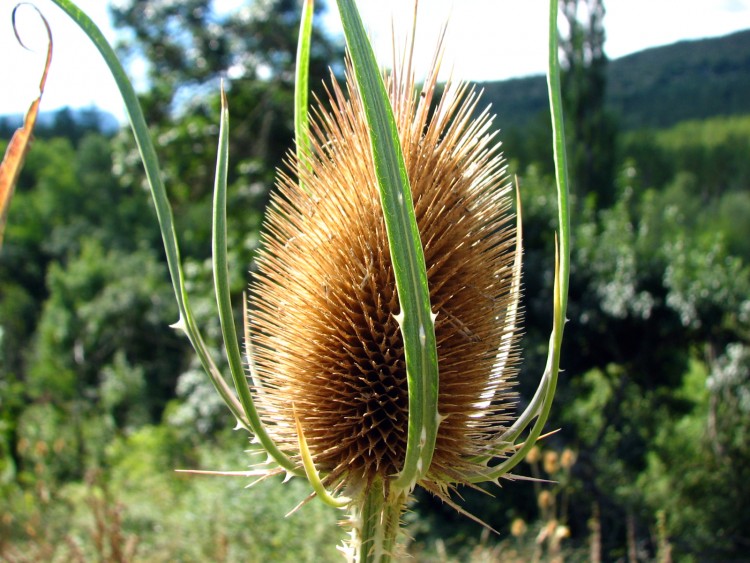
<box><xmin>338</xmin><ymin>0</ymin><xmax>439</xmax><ymax>490</ymax></box>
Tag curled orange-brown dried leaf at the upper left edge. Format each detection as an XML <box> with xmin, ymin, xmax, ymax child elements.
<box><xmin>0</xmin><ymin>4</ymin><xmax>52</xmax><ymax>246</ymax></box>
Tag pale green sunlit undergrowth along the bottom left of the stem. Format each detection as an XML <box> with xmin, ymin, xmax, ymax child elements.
<box><xmin>0</xmin><ymin>426</ymin><xmax>340</xmax><ymax>562</ymax></box>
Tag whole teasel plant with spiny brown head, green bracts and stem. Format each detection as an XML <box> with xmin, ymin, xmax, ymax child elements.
<box><xmin>11</xmin><ymin>0</ymin><xmax>569</xmax><ymax>561</ymax></box>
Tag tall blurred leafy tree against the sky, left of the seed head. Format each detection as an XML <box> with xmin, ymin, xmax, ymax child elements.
<box><xmin>113</xmin><ymin>0</ymin><xmax>341</xmax><ymax>260</ymax></box>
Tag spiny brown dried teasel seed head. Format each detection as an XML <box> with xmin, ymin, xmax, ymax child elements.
<box><xmin>251</xmin><ymin>48</ymin><xmax>518</xmax><ymax>498</ymax></box>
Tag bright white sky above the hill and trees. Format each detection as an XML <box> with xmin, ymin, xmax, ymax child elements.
<box><xmin>0</xmin><ymin>0</ymin><xmax>750</xmax><ymax>121</ymax></box>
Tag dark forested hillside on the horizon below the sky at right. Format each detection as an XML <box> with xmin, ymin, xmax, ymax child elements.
<box><xmin>479</xmin><ymin>30</ymin><xmax>750</xmax><ymax>130</ymax></box>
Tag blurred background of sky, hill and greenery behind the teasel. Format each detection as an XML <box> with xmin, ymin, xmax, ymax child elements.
<box><xmin>0</xmin><ymin>0</ymin><xmax>750</xmax><ymax>562</ymax></box>
